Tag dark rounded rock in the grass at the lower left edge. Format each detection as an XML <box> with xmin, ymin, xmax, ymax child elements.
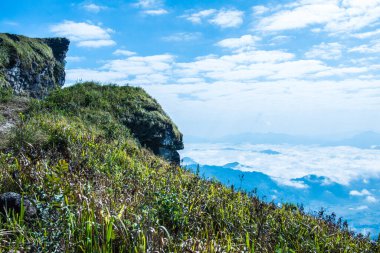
<box><xmin>0</xmin><ymin>192</ymin><xmax>37</xmax><ymax>219</ymax></box>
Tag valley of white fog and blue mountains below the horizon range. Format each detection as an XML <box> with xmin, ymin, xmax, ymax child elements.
<box><xmin>181</xmin><ymin>143</ymin><xmax>380</xmax><ymax>238</ymax></box>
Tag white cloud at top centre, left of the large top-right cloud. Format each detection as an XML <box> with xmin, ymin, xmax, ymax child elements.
<box><xmin>182</xmin><ymin>9</ymin><xmax>244</xmax><ymax>28</ymax></box>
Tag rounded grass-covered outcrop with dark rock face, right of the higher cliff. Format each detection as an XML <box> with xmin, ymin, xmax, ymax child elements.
<box><xmin>44</xmin><ymin>82</ymin><xmax>183</xmax><ymax>164</ymax></box>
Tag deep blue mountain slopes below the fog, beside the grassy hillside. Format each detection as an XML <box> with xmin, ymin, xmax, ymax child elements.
<box><xmin>181</xmin><ymin>157</ymin><xmax>380</xmax><ymax>238</ymax></box>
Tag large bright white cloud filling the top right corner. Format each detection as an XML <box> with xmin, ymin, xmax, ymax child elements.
<box><xmin>256</xmin><ymin>0</ymin><xmax>380</xmax><ymax>35</ymax></box>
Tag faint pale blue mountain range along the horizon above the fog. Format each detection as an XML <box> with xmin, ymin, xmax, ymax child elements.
<box><xmin>185</xmin><ymin>131</ymin><xmax>380</xmax><ymax>149</ymax></box>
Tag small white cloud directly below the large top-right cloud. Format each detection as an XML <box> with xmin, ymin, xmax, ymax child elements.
<box><xmin>305</xmin><ymin>42</ymin><xmax>343</xmax><ymax>60</ymax></box>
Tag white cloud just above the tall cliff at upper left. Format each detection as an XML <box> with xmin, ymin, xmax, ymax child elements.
<box><xmin>50</xmin><ymin>20</ymin><xmax>116</xmax><ymax>48</ymax></box>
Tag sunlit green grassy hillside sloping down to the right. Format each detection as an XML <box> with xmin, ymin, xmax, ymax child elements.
<box><xmin>0</xmin><ymin>83</ymin><xmax>380</xmax><ymax>252</ymax></box>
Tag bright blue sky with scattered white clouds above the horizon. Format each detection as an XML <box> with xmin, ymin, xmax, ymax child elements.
<box><xmin>0</xmin><ymin>0</ymin><xmax>380</xmax><ymax>140</ymax></box>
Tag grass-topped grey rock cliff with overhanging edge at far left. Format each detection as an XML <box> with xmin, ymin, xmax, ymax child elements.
<box><xmin>0</xmin><ymin>33</ymin><xmax>70</xmax><ymax>98</ymax></box>
